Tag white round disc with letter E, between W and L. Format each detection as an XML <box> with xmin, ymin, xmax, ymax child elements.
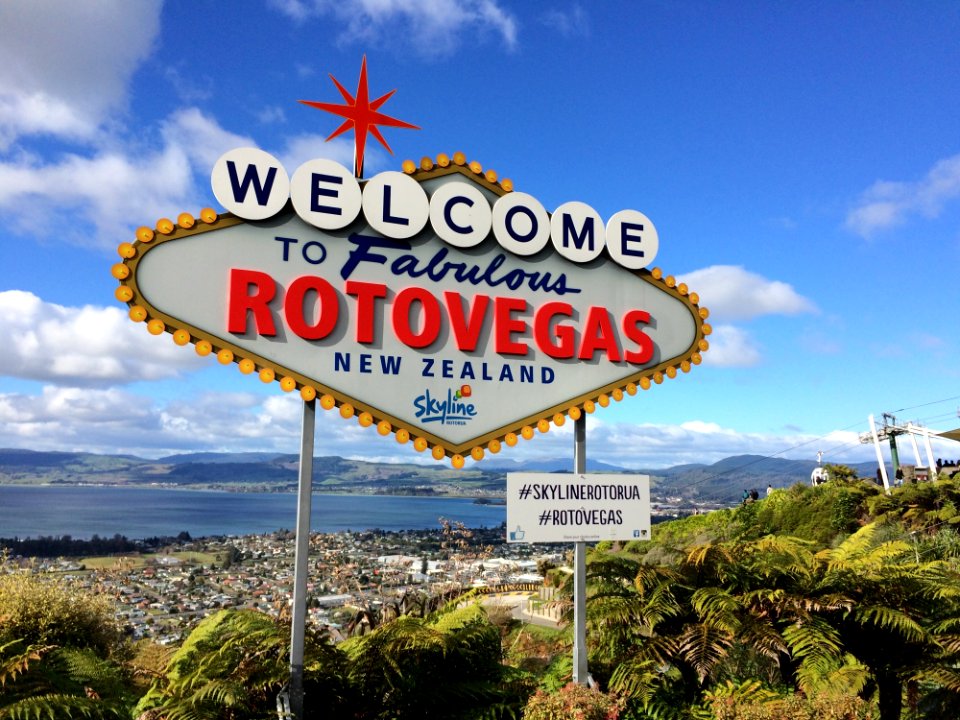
<box><xmin>290</xmin><ymin>158</ymin><xmax>361</xmax><ymax>230</ymax></box>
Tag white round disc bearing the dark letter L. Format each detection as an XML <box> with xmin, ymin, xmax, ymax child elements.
<box><xmin>363</xmin><ymin>170</ymin><xmax>430</xmax><ymax>240</ymax></box>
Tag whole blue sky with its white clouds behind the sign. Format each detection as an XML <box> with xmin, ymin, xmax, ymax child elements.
<box><xmin>0</xmin><ymin>0</ymin><xmax>960</xmax><ymax>468</ymax></box>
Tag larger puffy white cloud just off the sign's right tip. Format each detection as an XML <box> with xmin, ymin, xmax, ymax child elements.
<box><xmin>678</xmin><ymin>265</ymin><xmax>817</xmax><ymax>322</ymax></box>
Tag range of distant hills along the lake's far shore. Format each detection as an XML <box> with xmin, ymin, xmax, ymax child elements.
<box><xmin>0</xmin><ymin>449</ymin><xmax>876</xmax><ymax>505</ymax></box>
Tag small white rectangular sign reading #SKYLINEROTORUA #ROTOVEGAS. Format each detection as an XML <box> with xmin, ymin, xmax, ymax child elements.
<box><xmin>507</xmin><ymin>473</ymin><xmax>650</xmax><ymax>543</ymax></box>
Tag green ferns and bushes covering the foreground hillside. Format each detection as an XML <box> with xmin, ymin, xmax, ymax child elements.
<box><xmin>0</xmin><ymin>467</ymin><xmax>960</xmax><ymax>720</ymax></box>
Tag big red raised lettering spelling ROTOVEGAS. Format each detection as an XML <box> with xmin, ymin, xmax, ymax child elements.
<box><xmin>227</xmin><ymin>268</ymin><xmax>654</xmax><ymax>365</ymax></box>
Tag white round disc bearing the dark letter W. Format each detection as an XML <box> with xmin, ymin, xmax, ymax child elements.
<box><xmin>210</xmin><ymin>148</ymin><xmax>290</xmax><ymax>220</ymax></box>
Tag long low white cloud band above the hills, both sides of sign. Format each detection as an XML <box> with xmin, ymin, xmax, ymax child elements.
<box><xmin>0</xmin><ymin>374</ymin><xmax>900</xmax><ymax>470</ymax></box>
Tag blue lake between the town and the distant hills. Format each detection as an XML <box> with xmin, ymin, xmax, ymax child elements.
<box><xmin>0</xmin><ymin>485</ymin><xmax>506</xmax><ymax>540</ymax></box>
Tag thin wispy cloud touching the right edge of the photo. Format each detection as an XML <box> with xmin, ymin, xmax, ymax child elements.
<box><xmin>846</xmin><ymin>155</ymin><xmax>960</xmax><ymax>238</ymax></box>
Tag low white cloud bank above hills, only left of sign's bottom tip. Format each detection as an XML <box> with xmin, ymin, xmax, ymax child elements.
<box><xmin>0</xmin><ymin>382</ymin><xmax>434</xmax><ymax>456</ymax></box>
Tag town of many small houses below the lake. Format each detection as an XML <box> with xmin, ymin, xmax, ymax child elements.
<box><xmin>0</xmin><ymin>521</ymin><xmax>565</xmax><ymax>644</ymax></box>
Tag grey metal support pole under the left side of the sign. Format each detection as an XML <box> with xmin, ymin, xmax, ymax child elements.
<box><xmin>290</xmin><ymin>400</ymin><xmax>317</xmax><ymax>720</ymax></box>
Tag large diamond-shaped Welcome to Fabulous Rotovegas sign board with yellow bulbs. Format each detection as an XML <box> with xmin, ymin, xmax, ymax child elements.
<box><xmin>113</xmin><ymin>148</ymin><xmax>710</xmax><ymax>467</ymax></box>
